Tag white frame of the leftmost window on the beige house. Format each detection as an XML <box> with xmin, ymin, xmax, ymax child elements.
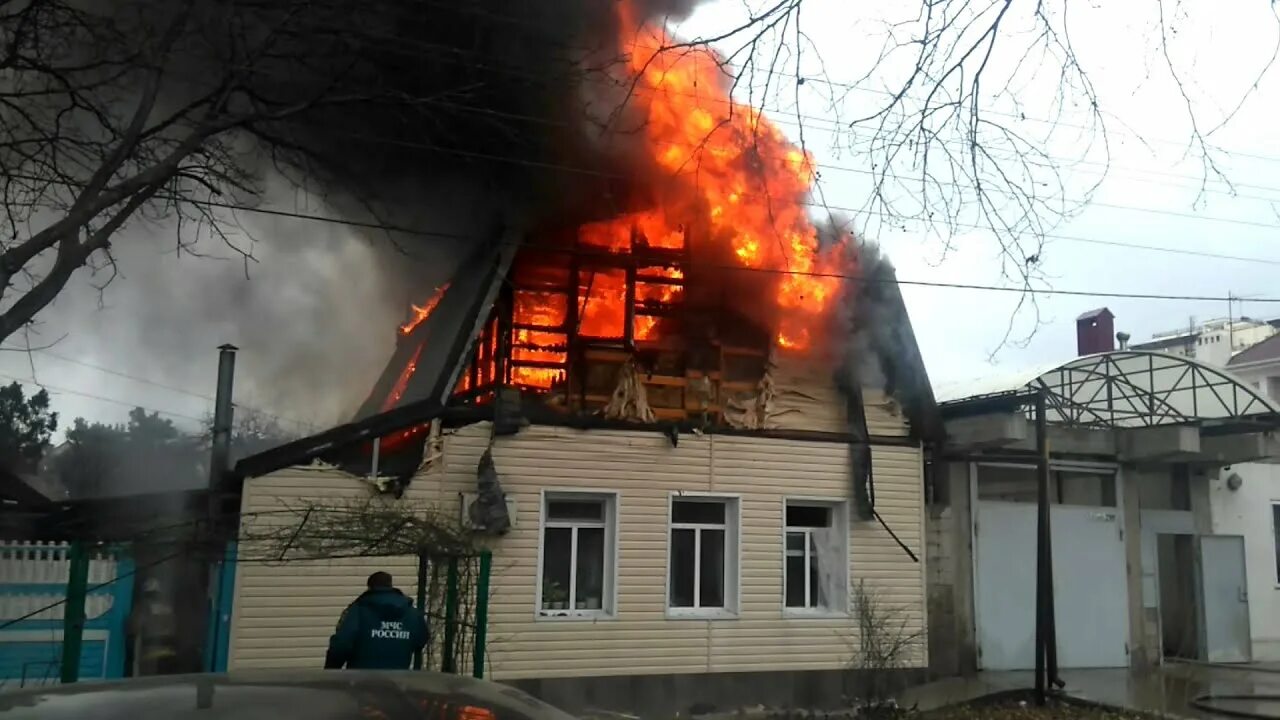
<box><xmin>534</xmin><ymin>488</ymin><xmax>622</xmax><ymax>621</ymax></box>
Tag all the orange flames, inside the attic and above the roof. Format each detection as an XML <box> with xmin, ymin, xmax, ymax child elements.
<box><xmin>401</xmin><ymin>0</ymin><xmax>841</xmax><ymax>388</ymax></box>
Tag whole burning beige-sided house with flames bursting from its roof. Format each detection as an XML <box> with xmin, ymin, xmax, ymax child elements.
<box><xmin>220</xmin><ymin>4</ymin><xmax>938</xmax><ymax>711</ymax></box>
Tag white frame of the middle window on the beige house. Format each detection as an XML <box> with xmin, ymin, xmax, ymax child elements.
<box><xmin>663</xmin><ymin>491</ymin><xmax>742</xmax><ymax>620</ymax></box>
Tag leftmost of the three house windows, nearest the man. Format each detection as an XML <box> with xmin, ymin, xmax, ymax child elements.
<box><xmin>538</xmin><ymin>493</ymin><xmax>617</xmax><ymax>618</ymax></box>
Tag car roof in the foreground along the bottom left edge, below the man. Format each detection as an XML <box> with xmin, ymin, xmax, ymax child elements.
<box><xmin>0</xmin><ymin>670</ymin><xmax>571</xmax><ymax>720</ymax></box>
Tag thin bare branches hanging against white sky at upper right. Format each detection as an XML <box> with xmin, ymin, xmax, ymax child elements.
<box><xmin>637</xmin><ymin>0</ymin><xmax>1280</xmax><ymax>341</ymax></box>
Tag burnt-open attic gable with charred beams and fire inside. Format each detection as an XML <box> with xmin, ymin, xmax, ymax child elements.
<box><xmin>399</xmin><ymin>223</ymin><xmax>787</xmax><ymax>428</ymax></box>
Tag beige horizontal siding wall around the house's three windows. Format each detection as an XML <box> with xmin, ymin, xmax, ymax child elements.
<box><xmin>232</xmin><ymin>424</ymin><xmax>925</xmax><ymax>679</ymax></box>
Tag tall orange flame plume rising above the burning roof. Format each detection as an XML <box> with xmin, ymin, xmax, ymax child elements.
<box><xmin>614</xmin><ymin>3</ymin><xmax>841</xmax><ymax>350</ymax></box>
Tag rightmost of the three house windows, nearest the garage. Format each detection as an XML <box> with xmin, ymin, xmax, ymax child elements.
<box><xmin>782</xmin><ymin>500</ymin><xmax>849</xmax><ymax>612</ymax></box>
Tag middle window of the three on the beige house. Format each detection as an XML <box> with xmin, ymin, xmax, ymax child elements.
<box><xmin>667</xmin><ymin>496</ymin><xmax>737</xmax><ymax>615</ymax></box>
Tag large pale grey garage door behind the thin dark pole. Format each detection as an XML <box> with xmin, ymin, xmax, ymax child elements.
<box><xmin>974</xmin><ymin>465</ymin><xmax>1129</xmax><ymax>670</ymax></box>
